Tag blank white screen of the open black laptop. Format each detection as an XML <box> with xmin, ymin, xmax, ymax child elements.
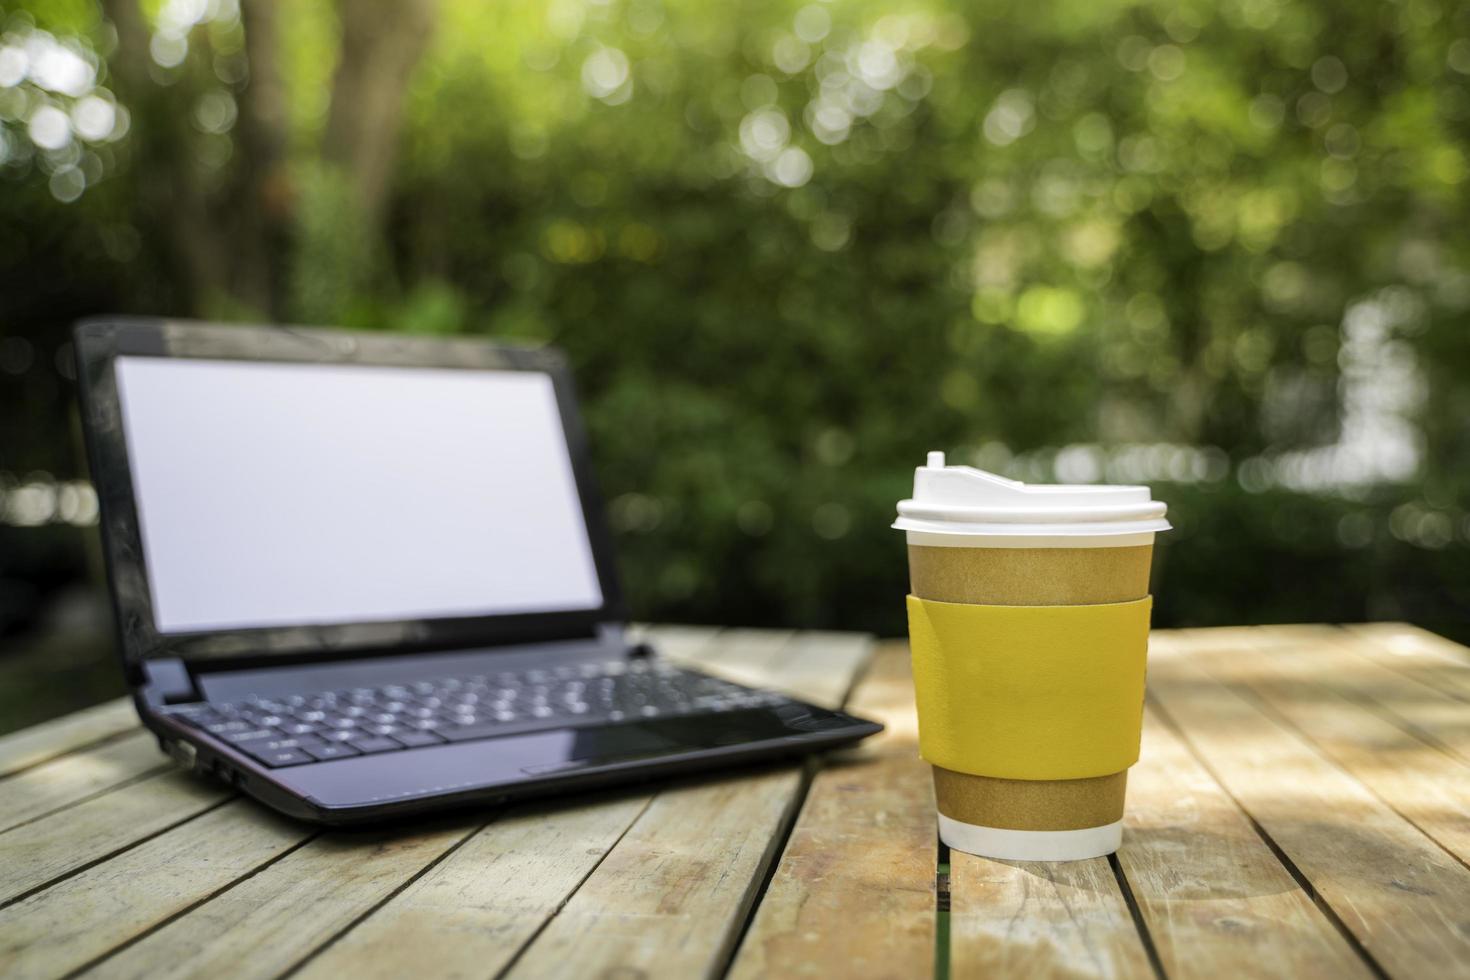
<box><xmin>108</xmin><ymin>357</ymin><xmax>603</xmax><ymax>633</ymax></box>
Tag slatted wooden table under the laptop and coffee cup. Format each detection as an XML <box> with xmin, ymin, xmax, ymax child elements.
<box><xmin>0</xmin><ymin>624</ymin><xmax>1470</xmax><ymax>980</ymax></box>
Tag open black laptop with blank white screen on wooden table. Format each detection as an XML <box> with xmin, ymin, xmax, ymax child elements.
<box><xmin>75</xmin><ymin>317</ymin><xmax>881</xmax><ymax>824</ymax></box>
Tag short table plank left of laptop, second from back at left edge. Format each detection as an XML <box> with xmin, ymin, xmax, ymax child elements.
<box><xmin>0</xmin><ymin>732</ymin><xmax>172</xmax><ymax>830</ymax></box>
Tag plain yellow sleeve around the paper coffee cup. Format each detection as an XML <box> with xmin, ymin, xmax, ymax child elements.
<box><xmin>908</xmin><ymin>595</ymin><xmax>1152</xmax><ymax>779</ymax></box>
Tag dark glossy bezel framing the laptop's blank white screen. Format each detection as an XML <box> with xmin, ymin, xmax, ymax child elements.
<box><xmin>75</xmin><ymin>317</ymin><xmax>625</xmax><ymax>666</ymax></box>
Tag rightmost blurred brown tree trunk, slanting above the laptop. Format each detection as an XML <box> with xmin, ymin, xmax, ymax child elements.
<box><xmin>322</xmin><ymin>0</ymin><xmax>438</xmax><ymax>229</ymax></box>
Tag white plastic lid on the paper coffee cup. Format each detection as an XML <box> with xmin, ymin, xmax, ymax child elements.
<box><xmin>894</xmin><ymin>453</ymin><xmax>1169</xmax><ymax>539</ymax></box>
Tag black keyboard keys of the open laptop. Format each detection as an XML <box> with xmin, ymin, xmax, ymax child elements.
<box><xmin>168</xmin><ymin>660</ymin><xmax>789</xmax><ymax>767</ymax></box>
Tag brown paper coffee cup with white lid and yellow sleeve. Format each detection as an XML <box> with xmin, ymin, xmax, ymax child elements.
<box><xmin>894</xmin><ymin>453</ymin><xmax>1169</xmax><ymax>861</ymax></box>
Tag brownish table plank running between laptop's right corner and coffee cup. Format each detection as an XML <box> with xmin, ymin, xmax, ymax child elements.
<box><xmin>731</xmin><ymin>644</ymin><xmax>938</xmax><ymax>980</ymax></box>
